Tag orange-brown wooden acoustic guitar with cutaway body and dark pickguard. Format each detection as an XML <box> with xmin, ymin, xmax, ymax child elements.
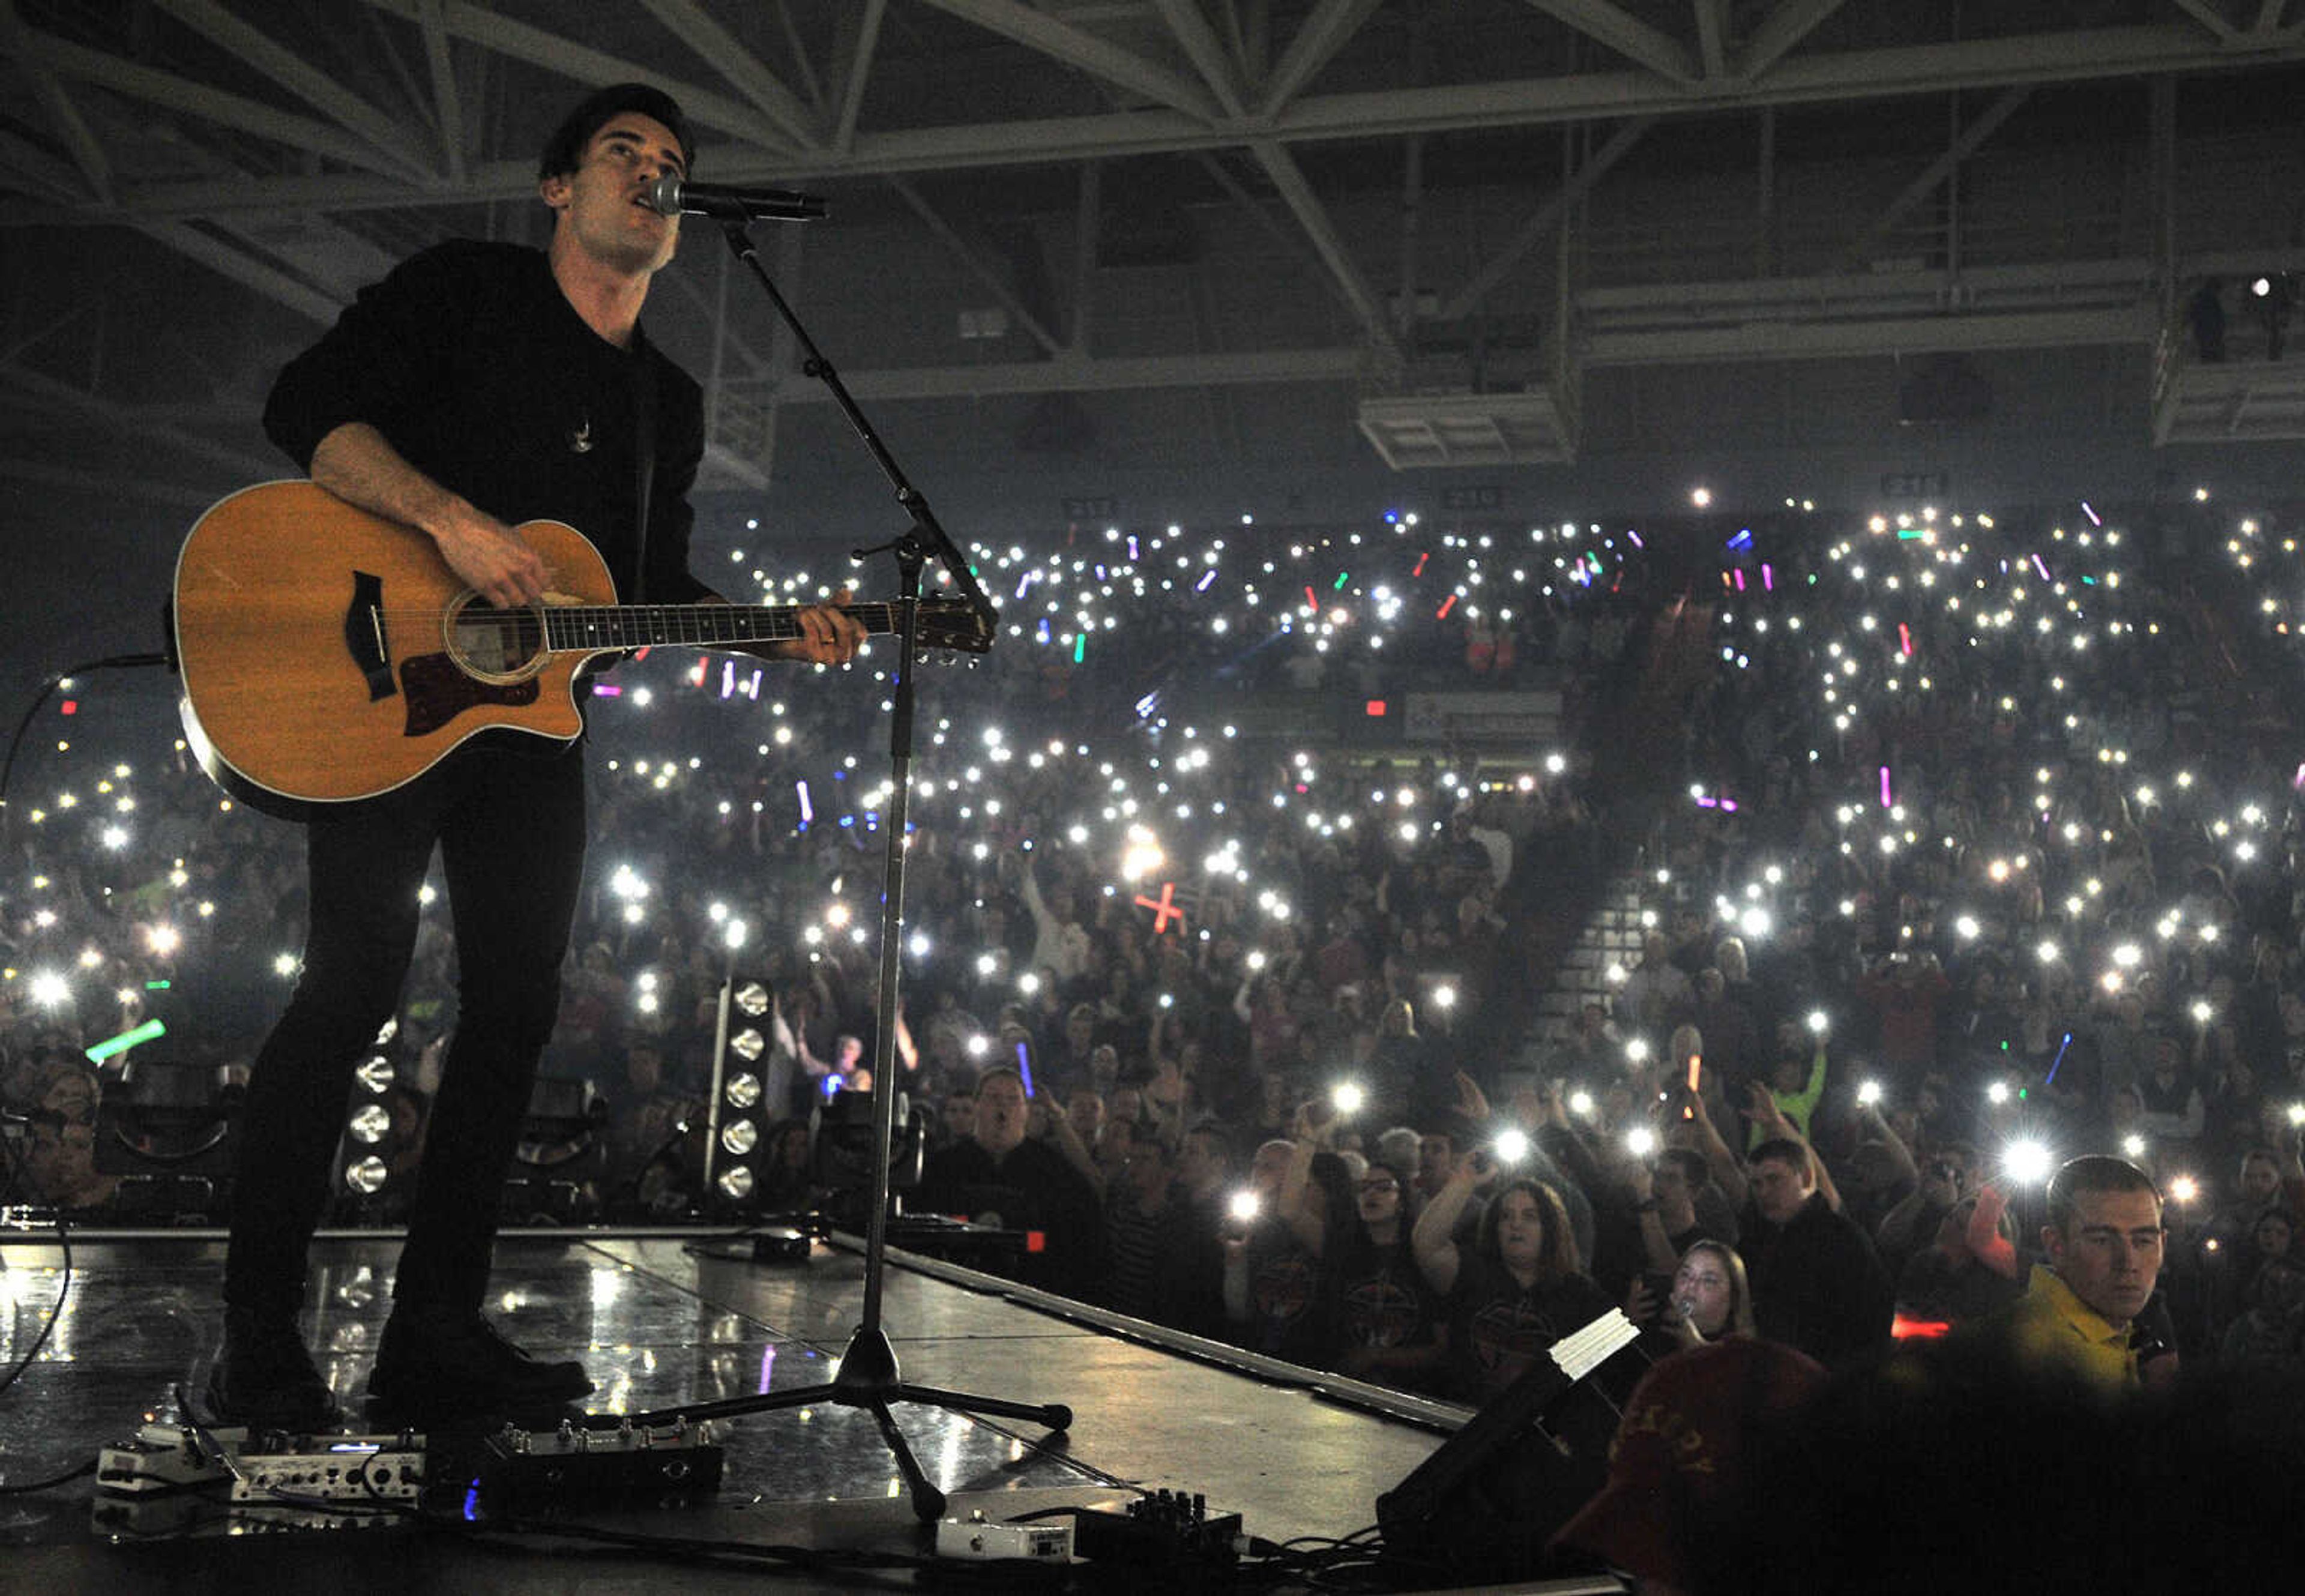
<box><xmin>173</xmin><ymin>482</ymin><xmax>993</xmax><ymax>819</ymax></box>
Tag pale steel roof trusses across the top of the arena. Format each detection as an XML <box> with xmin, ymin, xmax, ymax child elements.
<box><xmin>0</xmin><ymin>0</ymin><xmax>2305</xmax><ymax>489</ymax></box>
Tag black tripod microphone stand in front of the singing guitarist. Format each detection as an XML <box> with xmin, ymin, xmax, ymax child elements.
<box><xmin>634</xmin><ymin>214</ymin><xmax>1072</xmax><ymax>1522</ymax></box>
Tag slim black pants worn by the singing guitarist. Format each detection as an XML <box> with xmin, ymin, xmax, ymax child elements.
<box><xmin>223</xmin><ymin>738</ymin><xmax>585</xmax><ymax>1314</ymax></box>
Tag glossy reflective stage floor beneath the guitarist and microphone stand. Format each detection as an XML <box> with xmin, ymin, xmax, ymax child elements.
<box><xmin>0</xmin><ymin>1236</ymin><xmax>1576</xmax><ymax>1596</ymax></box>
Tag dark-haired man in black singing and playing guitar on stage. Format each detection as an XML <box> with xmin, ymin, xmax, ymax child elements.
<box><xmin>208</xmin><ymin>83</ymin><xmax>864</xmax><ymax>1432</ymax></box>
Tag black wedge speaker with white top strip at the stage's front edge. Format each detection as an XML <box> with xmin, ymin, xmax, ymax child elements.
<box><xmin>1376</xmin><ymin>1308</ymin><xmax>1639</xmax><ymax>1587</ymax></box>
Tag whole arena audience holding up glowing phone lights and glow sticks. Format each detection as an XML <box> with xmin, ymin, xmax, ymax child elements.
<box><xmin>0</xmin><ymin>482</ymin><xmax>2305</xmax><ymax>1430</ymax></box>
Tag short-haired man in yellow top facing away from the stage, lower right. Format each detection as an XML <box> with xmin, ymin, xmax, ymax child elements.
<box><xmin>1996</xmin><ymin>1153</ymin><xmax>2162</xmax><ymax>1391</ymax></box>
